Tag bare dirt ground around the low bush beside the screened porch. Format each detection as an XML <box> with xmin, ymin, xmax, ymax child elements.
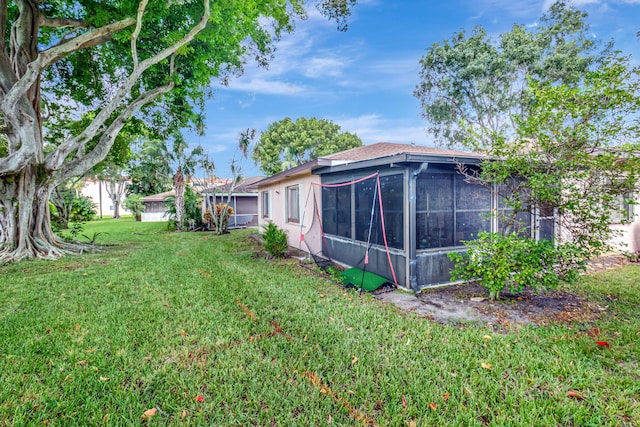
<box><xmin>375</xmin><ymin>255</ymin><xmax>627</xmax><ymax>329</ymax></box>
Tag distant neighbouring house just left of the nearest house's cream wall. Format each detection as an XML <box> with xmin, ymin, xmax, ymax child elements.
<box><xmin>202</xmin><ymin>176</ymin><xmax>262</xmax><ymax>228</ymax></box>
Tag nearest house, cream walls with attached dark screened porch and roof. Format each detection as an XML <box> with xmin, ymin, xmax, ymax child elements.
<box><xmin>256</xmin><ymin>143</ymin><xmax>555</xmax><ymax>290</ymax></box>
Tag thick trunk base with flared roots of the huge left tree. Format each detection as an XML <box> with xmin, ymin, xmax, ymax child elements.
<box><xmin>0</xmin><ymin>164</ymin><xmax>88</xmax><ymax>263</ymax></box>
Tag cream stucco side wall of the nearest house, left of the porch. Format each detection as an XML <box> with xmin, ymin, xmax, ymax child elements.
<box><xmin>258</xmin><ymin>173</ymin><xmax>322</xmax><ymax>254</ymax></box>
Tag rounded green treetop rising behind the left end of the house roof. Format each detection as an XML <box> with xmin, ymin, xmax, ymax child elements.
<box><xmin>251</xmin><ymin>117</ymin><xmax>362</xmax><ymax>175</ymax></box>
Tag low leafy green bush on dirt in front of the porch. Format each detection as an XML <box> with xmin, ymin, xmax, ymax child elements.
<box><xmin>449</xmin><ymin>232</ymin><xmax>584</xmax><ymax>300</ymax></box>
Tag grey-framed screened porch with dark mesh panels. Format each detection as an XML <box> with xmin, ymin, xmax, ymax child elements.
<box><xmin>313</xmin><ymin>152</ymin><xmax>554</xmax><ymax>290</ymax></box>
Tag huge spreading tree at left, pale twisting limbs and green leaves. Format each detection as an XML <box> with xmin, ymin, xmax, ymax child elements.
<box><xmin>0</xmin><ymin>0</ymin><xmax>355</xmax><ymax>262</ymax></box>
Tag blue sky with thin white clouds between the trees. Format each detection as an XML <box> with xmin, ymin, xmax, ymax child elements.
<box><xmin>186</xmin><ymin>0</ymin><xmax>640</xmax><ymax>177</ymax></box>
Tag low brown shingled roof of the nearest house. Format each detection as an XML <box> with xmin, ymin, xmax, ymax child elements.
<box><xmin>254</xmin><ymin>142</ymin><xmax>485</xmax><ymax>188</ymax></box>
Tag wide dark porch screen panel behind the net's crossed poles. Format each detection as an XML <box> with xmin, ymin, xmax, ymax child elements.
<box><xmin>354</xmin><ymin>175</ymin><xmax>404</xmax><ymax>249</ymax></box>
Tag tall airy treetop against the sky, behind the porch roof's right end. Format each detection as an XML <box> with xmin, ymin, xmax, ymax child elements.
<box><xmin>414</xmin><ymin>1</ymin><xmax>610</xmax><ymax>150</ymax></box>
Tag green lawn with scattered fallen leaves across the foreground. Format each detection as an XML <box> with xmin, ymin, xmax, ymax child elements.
<box><xmin>0</xmin><ymin>219</ymin><xmax>640</xmax><ymax>426</ymax></box>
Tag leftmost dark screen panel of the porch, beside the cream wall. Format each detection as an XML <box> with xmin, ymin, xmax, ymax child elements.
<box><xmin>322</xmin><ymin>185</ymin><xmax>351</xmax><ymax>238</ymax></box>
